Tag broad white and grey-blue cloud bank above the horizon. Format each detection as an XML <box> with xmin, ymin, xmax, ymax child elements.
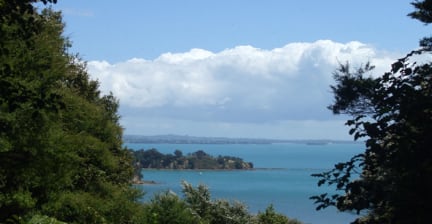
<box><xmin>88</xmin><ymin>40</ymin><xmax>399</xmax><ymax>137</ymax></box>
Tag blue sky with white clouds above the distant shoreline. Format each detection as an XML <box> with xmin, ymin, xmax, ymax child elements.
<box><xmin>44</xmin><ymin>0</ymin><xmax>430</xmax><ymax>140</ymax></box>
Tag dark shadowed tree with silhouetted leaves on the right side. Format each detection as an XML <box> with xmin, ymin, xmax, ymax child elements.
<box><xmin>311</xmin><ymin>0</ymin><xmax>432</xmax><ymax>223</ymax></box>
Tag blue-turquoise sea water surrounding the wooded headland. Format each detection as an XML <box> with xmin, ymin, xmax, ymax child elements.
<box><xmin>126</xmin><ymin>143</ymin><xmax>363</xmax><ymax>224</ymax></box>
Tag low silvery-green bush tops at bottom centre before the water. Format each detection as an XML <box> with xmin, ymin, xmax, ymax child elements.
<box><xmin>145</xmin><ymin>182</ymin><xmax>301</xmax><ymax>224</ymax></box>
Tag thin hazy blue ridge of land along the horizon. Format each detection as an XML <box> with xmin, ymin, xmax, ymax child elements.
<box><xmin>123</xmin><ymin>135</ymin><xmax>358</xmax><ymax>145</ymax></box>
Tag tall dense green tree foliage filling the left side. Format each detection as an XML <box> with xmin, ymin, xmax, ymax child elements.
<box><xmin>0</xmin><ymin>0</ymin><xmax>141</xmax><ymax>223</ymax></box>
